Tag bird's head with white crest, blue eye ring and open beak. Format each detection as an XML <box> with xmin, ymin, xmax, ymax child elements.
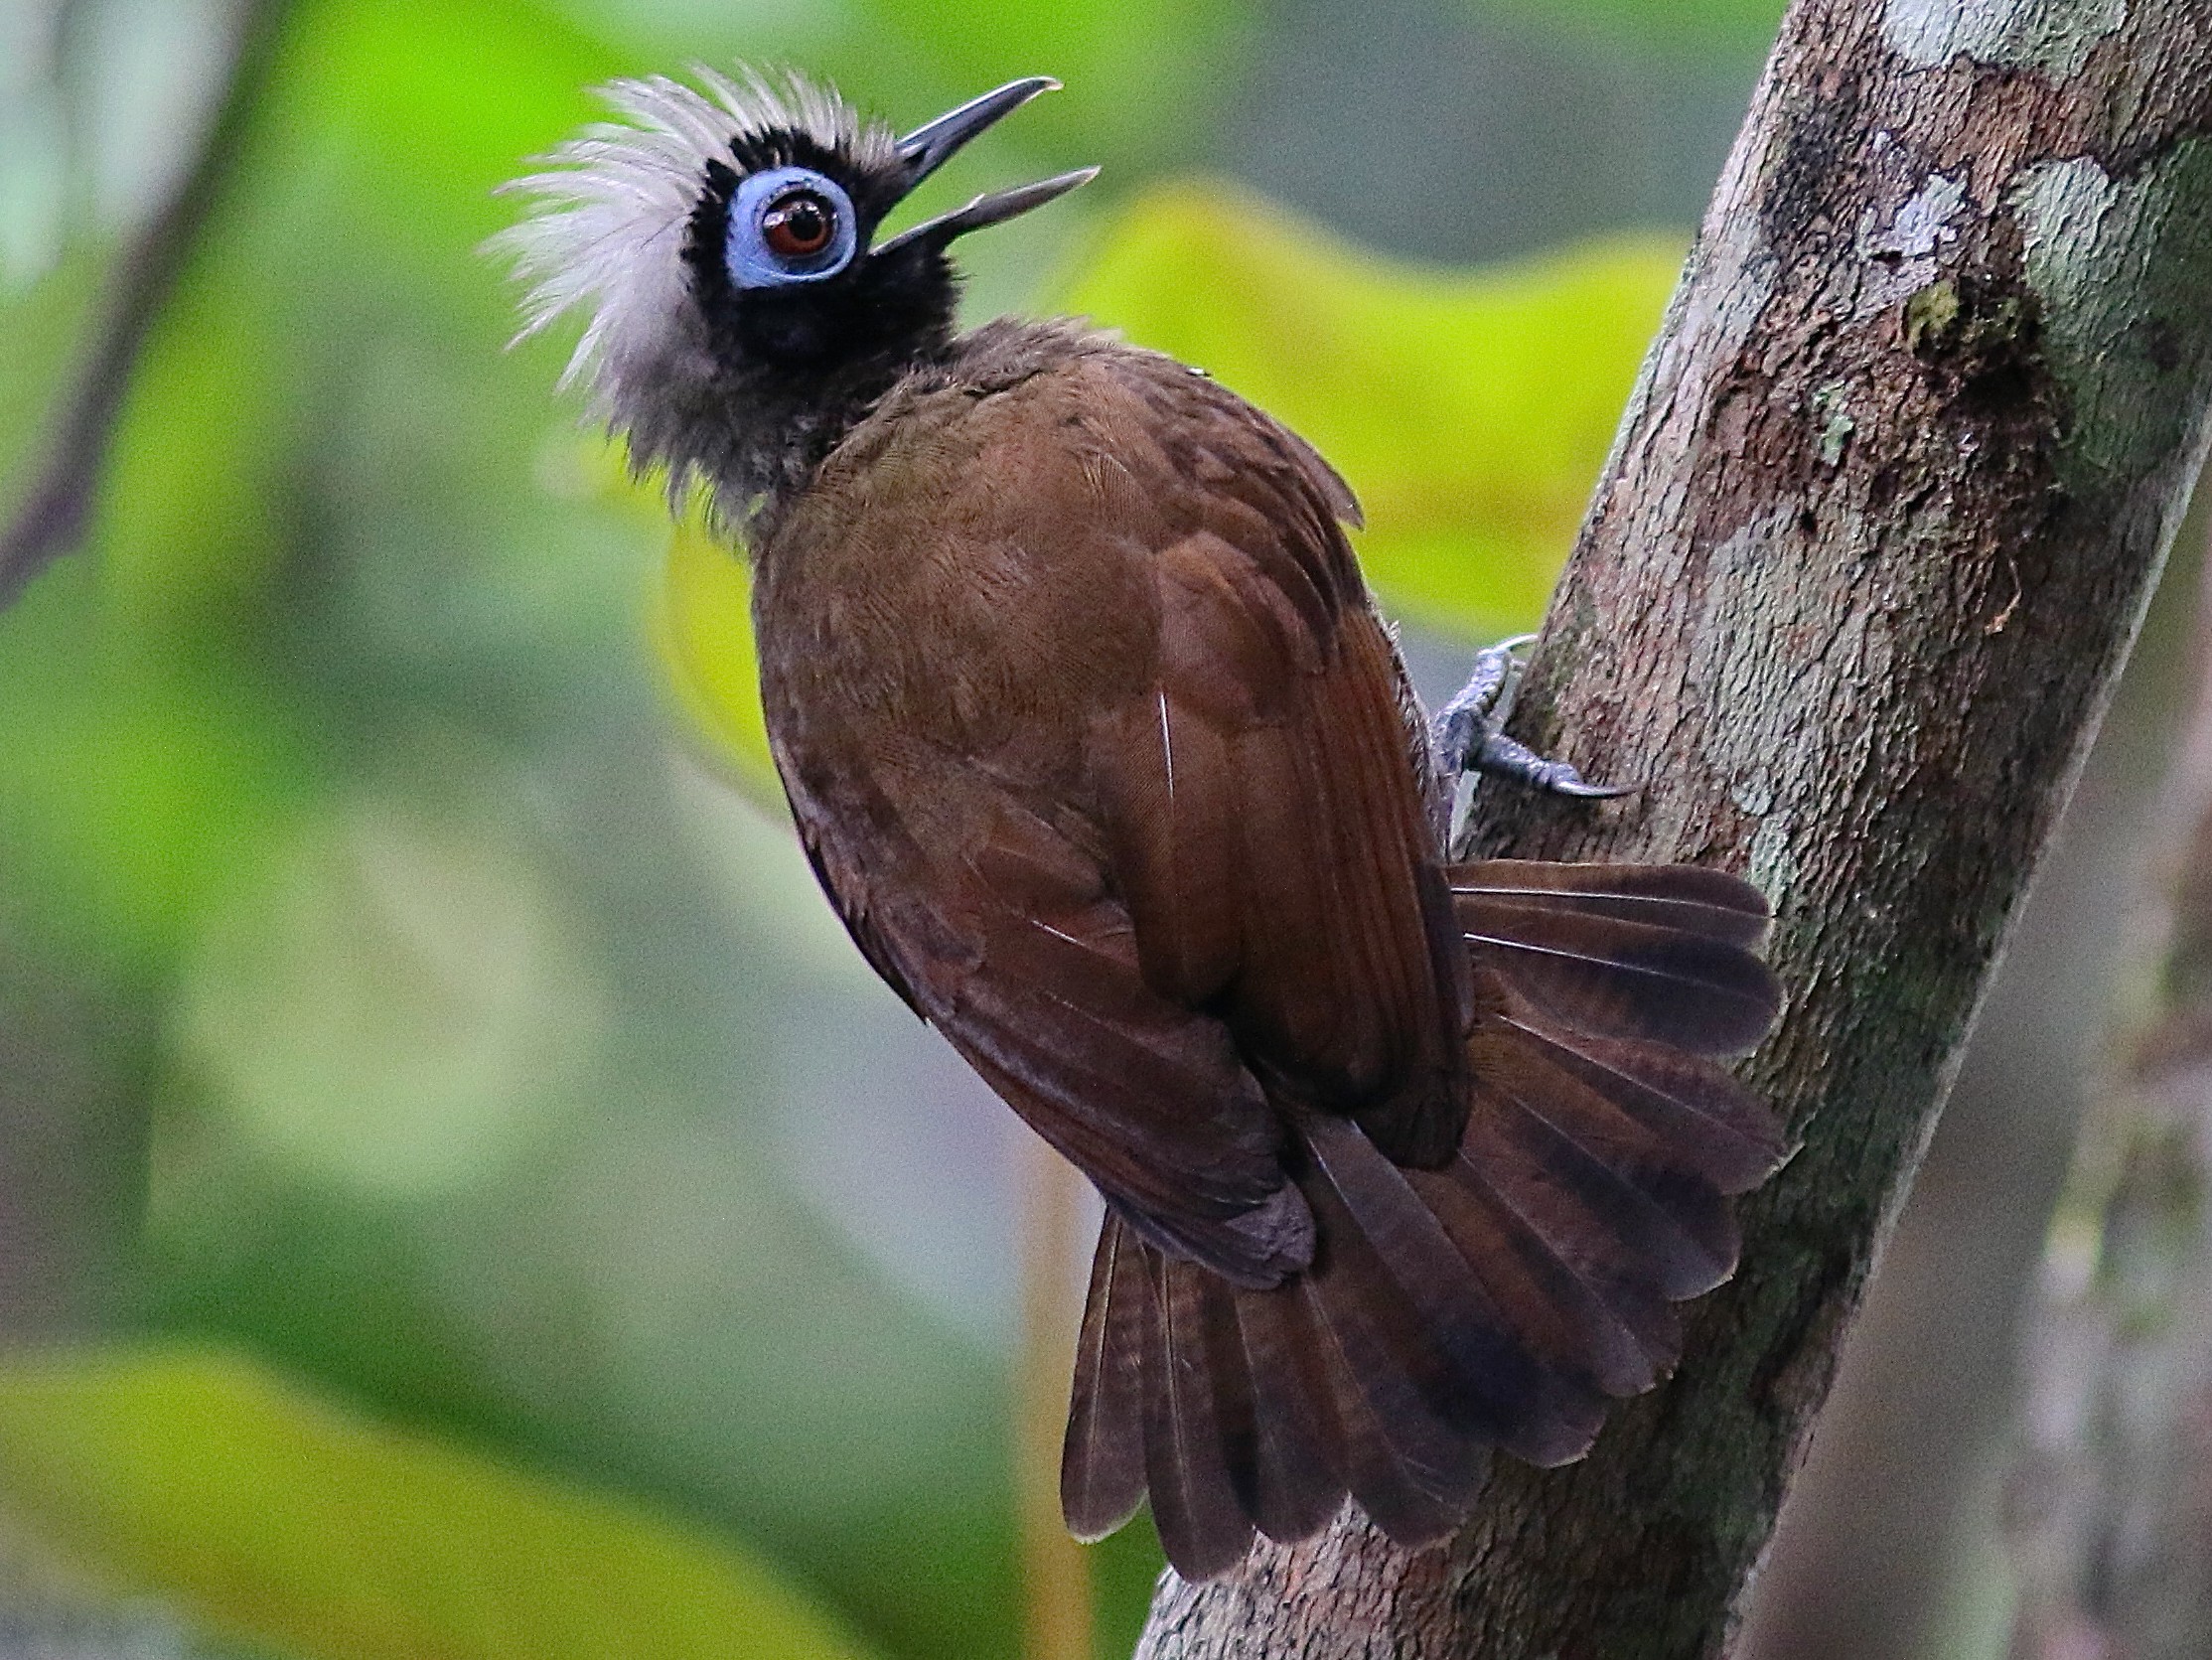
<box><xmin>494</xmin><ymin>71</ymin><xmax>1095</xmax><ymax>518</ymax></box>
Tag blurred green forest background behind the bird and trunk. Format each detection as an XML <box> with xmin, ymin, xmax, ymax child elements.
<box><xmin>0</xmin><ymin>0</ymin><xmax>2185</xmax><ymax>1660</ymax></box>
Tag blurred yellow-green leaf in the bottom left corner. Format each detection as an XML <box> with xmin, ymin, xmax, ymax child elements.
<box><xmin>0</xmin><ymin>1350</ymin><xmax>865</xmax><ymax>1660</ymax></box>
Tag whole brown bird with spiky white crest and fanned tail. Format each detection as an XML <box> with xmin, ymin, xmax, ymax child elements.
<box><xmin>496</xmin><ymin>69</ymin><xmax>1790</xmax><ymax>1581</ymax></box>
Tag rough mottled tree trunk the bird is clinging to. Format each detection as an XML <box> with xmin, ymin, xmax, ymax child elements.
<box><xmin>1139</xmin><ymin>0</ymin><xmax>2212</xmax><ymax>1660</ymax></box>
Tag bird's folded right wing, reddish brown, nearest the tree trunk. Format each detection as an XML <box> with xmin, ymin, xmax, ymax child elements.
<box><xmin>1091</xmin><ymin>357</ymin><xmax>1469</xmax><ymax>1164</ymax></box>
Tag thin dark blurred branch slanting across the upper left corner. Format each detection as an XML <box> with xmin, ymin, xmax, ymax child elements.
<box><xmin>0</xmin><ymin>0</ymin><xmax>290</xmax><ymax>609</ymax></box>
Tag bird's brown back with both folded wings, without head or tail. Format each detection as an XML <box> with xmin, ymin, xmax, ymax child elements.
<box><xmin>759</xmin><ymin>327</ymin><xmax>1467</xmax><ymax>1285</ymax></box>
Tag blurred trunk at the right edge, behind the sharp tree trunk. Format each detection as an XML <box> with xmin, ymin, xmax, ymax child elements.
<box><xmin>2008</xmin><ymin>522</ymin><xmax>2212</xmax><ymax>1660</ymax></box>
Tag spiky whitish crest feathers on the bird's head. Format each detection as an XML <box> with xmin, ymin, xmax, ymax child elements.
<box><xmin>487</xmin><ymin>69</ymin><xmax>896</xmax><ymax>435</ymax></box>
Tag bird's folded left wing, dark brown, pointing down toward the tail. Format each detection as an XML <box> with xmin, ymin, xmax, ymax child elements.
<box><xmin>774</xmin><ymin>748</ymin><xmax>1312</xmax><ymax>1285</ymax></box>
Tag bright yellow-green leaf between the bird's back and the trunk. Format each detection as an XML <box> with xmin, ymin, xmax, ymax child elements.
<box><xmin>1062</xmin><ymin>182</ymin><xmax>1682</xmax><ymax>635</ymax></box>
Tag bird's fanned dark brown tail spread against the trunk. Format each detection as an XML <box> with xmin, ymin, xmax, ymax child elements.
<box><xmin>1062</xmin><ymin>861</ymin><xmax>1787</xmax><ymax>1581</ymax></box>
